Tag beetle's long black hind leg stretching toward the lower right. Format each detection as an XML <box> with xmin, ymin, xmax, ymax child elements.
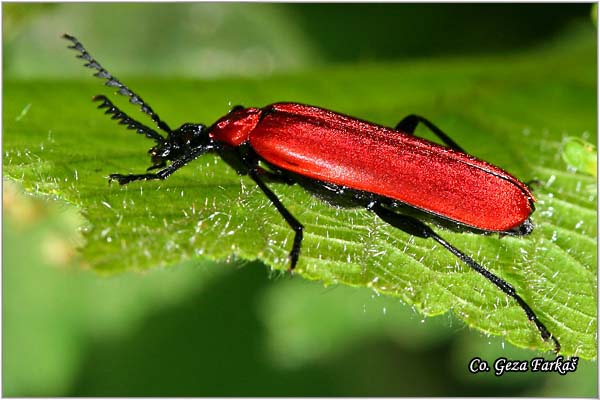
<box><xmin>367</xmin><ymin>202</ymin><xmax>560</xmax><ymax>353</ymax></box>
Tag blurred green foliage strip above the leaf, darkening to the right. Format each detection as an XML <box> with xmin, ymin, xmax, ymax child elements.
<box><xmin>3</xmin><ymin>3</ymin><xmax>590</xmax><ymax>78</ymax></box>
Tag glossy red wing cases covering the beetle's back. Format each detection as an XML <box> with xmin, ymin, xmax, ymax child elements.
<box><xmin>248</xmin><ymin>103</ymin><xmax>534</xmax><ymax>231</ymax></box>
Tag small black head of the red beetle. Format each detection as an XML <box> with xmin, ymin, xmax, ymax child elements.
<box><xmin>148</xmin><ymin>123</ymin><xmax>214</xmax><ymax>171</ymax></box>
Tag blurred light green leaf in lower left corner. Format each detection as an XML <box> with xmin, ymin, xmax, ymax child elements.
<box><xmin>2</xmin><ymin>182</ymin><xmax>232</xmax><ymax>397</ymax></box>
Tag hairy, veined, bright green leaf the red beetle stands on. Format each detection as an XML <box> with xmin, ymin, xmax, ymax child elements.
<box><xmin>4</xmin><ymin>25</ymin><xmax>597</xmax><ymax>358</ymax></box>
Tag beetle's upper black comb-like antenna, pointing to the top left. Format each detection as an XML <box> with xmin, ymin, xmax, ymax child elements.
<box><xmin>62</xmin><ymin>33</ymin><xmax>172</xmax><ymax>133</ymax></box>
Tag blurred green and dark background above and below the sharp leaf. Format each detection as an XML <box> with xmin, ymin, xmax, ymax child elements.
<box><xmin>3</xmin><ymin>3</ymin><xmax>597</xmax><ymax>397</ymax></box>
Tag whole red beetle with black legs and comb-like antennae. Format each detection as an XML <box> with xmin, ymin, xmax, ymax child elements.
<box><xmin>63</xmin><ymin>34</ymin><xmax>560</xmax><ymax>353</ymax></box>
